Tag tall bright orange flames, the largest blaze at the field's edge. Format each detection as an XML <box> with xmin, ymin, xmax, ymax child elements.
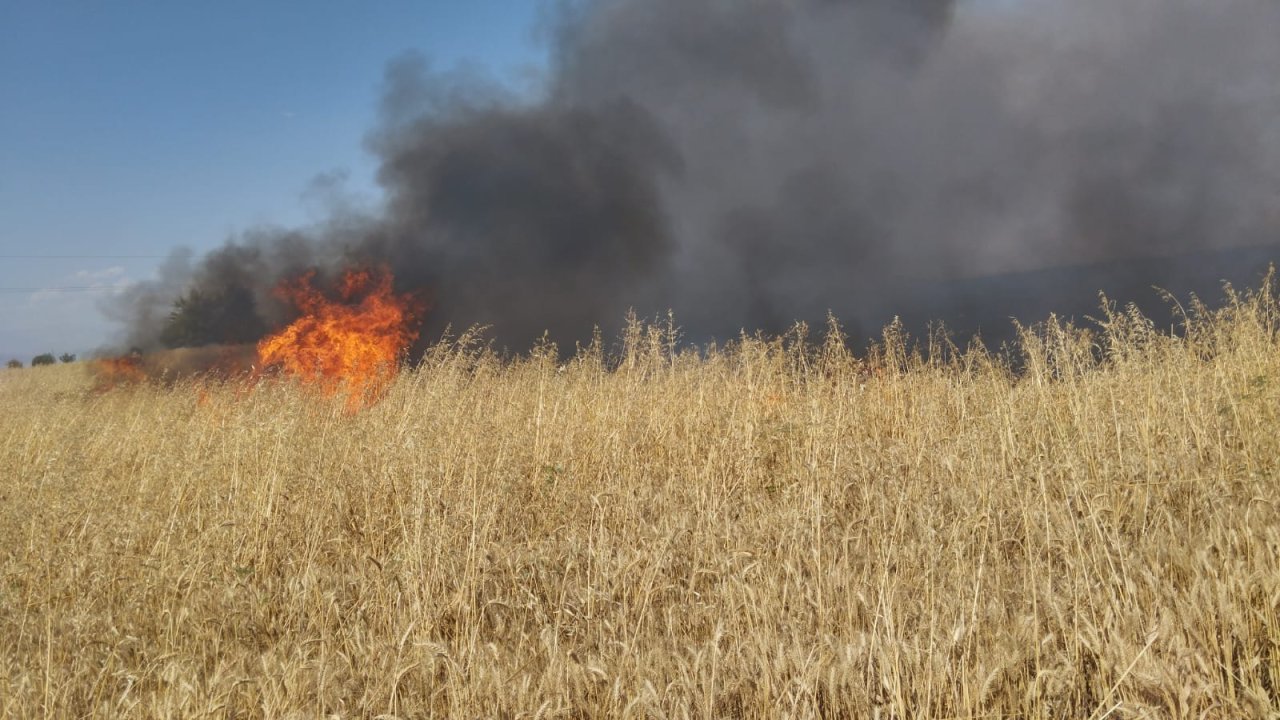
<box><xmin>257</xmin><ymin>269</ymin><xmax>425</xmax><ymax>410</ymax></box>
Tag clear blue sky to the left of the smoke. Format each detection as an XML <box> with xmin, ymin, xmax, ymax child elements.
<box><xmin>0</xmin><ymin>0</ymin><xmax>544</xmax><ymax>363</ymax></box>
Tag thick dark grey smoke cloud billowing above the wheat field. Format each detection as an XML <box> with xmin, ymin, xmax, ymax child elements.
<box><xmin>113</xmin><ymin>0</ymin><xmax>1280</xmax><ymax>348</ymax></box>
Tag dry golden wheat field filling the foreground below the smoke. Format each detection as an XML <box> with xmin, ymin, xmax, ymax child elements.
<box><xmin>0</xmin><ymin>284</ymin><xmax>1280</xmax><ymax>719</ymax></box>
